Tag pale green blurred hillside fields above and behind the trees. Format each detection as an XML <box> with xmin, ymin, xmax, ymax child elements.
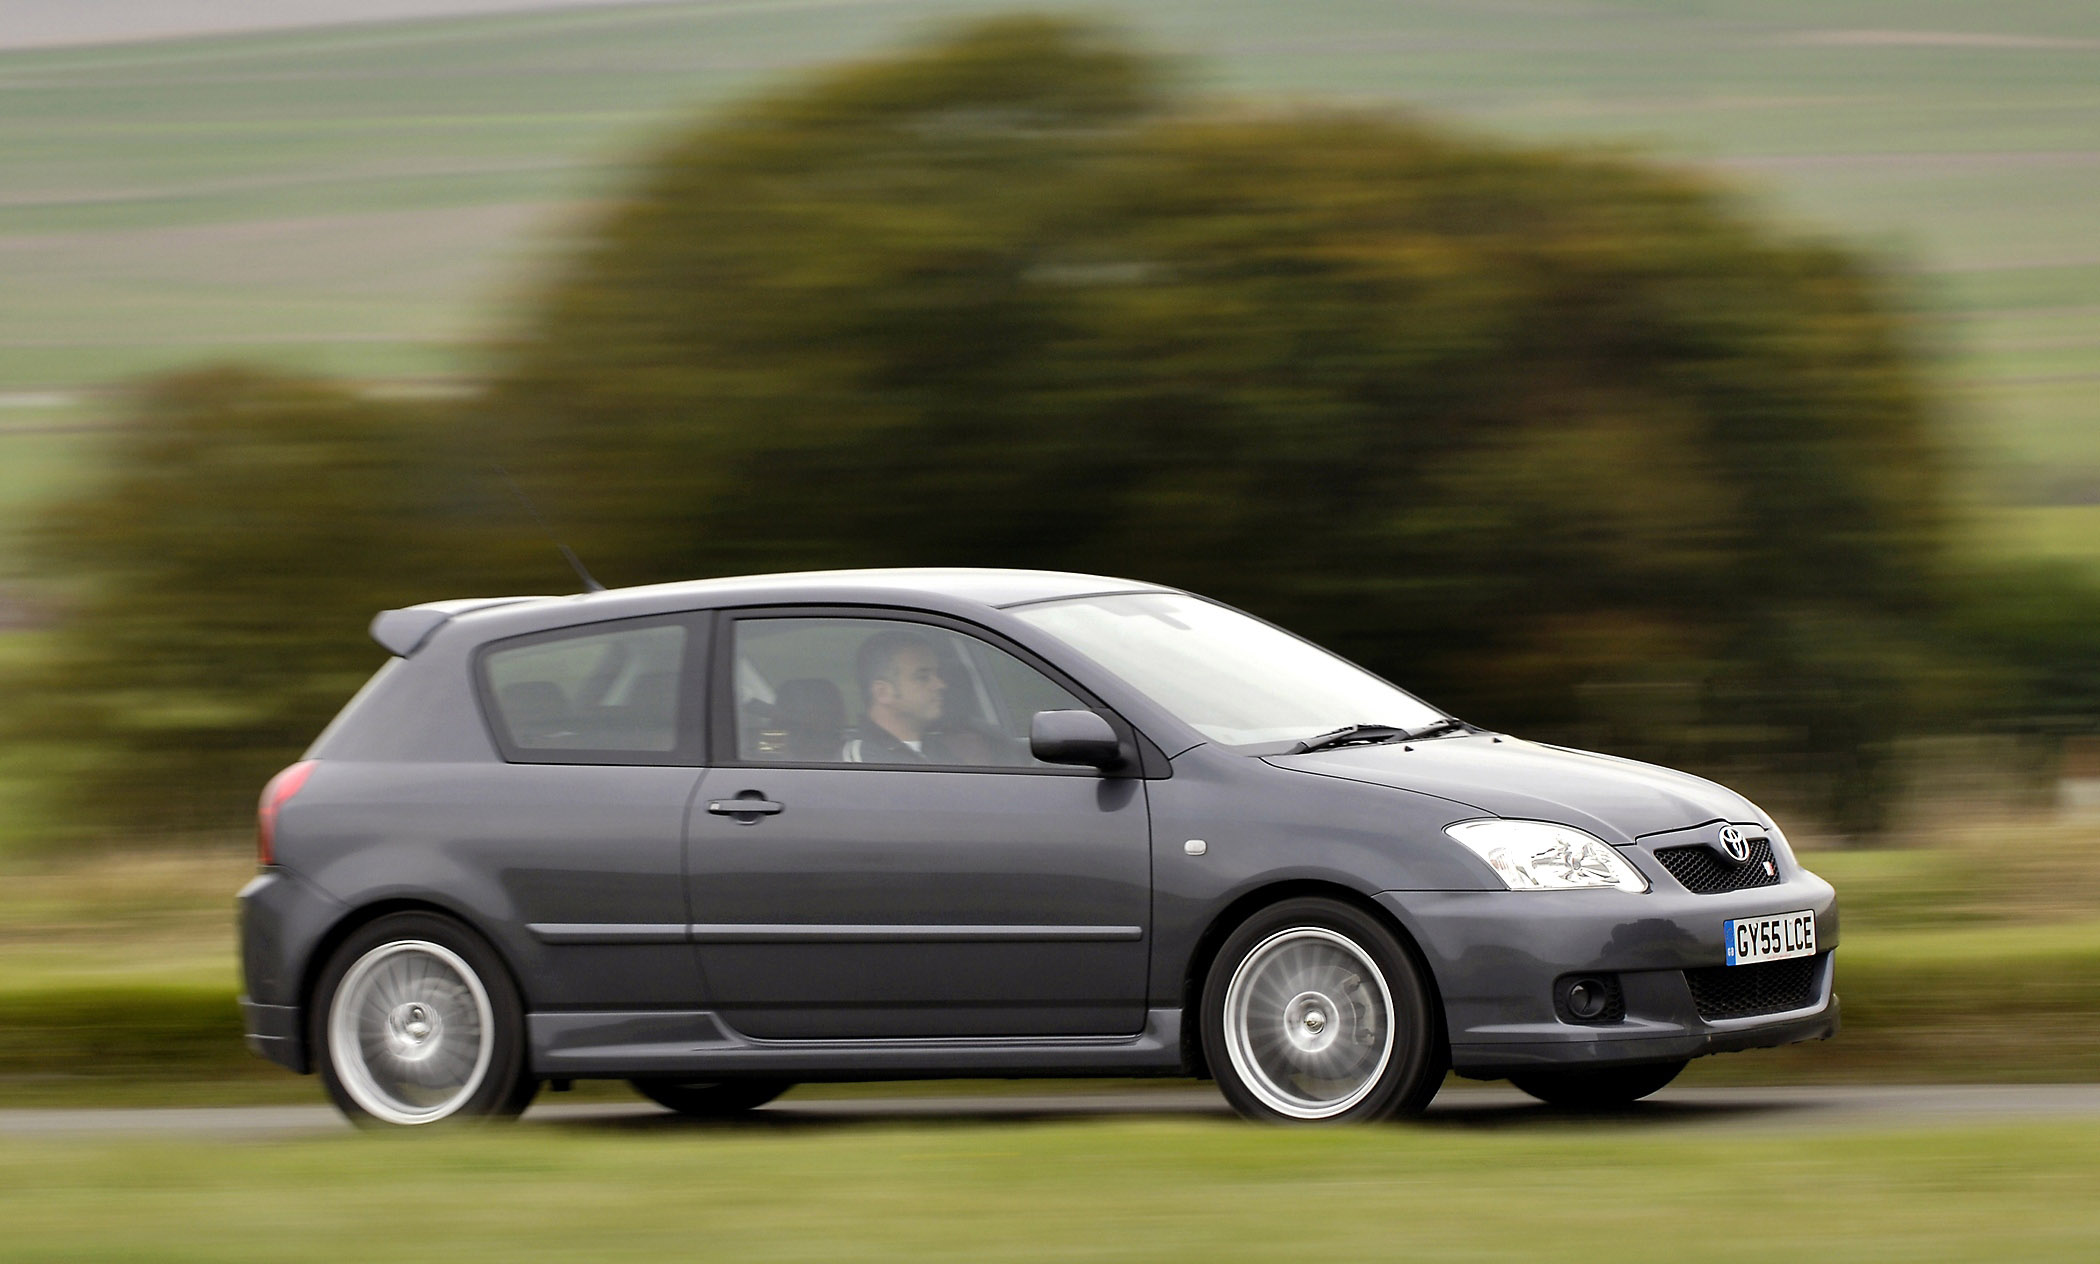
<box><xmin>0</xmin><ymin>0</ymin><xmax>2100</xmax><ymax>531</ymax></box>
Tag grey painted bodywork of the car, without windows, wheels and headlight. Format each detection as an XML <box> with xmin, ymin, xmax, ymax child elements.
<box><xmin>242</xmin><ymin>571</ymin><xmax>1838</xmax><ymax>1079</ymax></box>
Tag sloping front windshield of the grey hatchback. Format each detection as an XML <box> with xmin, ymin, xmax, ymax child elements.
<box><xmin>1012</xmin><ymin>592</ymin><xmax>1443</xmax><ymax>745</ymax></box>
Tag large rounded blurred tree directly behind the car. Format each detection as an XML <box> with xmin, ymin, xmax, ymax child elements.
<box><xmin>487</xmin><ymin>19</ymin><xmax>1957</xmax><ymax>827</ymax></box>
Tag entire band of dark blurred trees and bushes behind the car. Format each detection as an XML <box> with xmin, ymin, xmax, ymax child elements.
<box><xmin>11</xmin><ymin>19</ymin><xmax>2100</xmax><ymax>834</ymax></box>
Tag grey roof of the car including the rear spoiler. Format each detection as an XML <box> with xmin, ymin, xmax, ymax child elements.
<box><xmin>372</xmin><ymin>567</ymin><xmax>1174</xmax><ymax>657</ymax></box>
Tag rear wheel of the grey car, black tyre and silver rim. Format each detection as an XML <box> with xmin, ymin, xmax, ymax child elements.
<box><xmin>307</xmin><ymin>913</ymin><xmax>540</xmax><ymax>1128</ymax></box>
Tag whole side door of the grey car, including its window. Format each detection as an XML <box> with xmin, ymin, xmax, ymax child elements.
<box><xmin>687</xmin><ymin>609</ymin><xmax>1151</xmax><ymax>1039</ymax></box>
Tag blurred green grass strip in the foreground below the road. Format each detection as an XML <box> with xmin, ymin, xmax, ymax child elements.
<box><xmin>0</xmin><ymin>1121</ymin><xmax>2100</xmax><ymax>1264</ymax></box>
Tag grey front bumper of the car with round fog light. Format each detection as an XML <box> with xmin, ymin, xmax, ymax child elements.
<box><xmin>1378</xmin><ymin>865</ymin><xmax>1838</xmax><ymax>1079</ymax></box>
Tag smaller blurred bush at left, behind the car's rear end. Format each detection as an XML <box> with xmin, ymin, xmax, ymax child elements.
<box><xmin>6</xmin><ymin>370</ymin><xmax>533</xmax><ymax>831</ymax></box>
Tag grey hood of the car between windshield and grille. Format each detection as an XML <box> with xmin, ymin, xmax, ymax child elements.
<box><xmin>1266</xmin><ymin>735</ymin><xmax>1760</xmax><ymax>842</ymax></box>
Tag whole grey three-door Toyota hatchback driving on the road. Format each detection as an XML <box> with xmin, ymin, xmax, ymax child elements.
<box><xmin>239</xmin><ymin>569</ymin><xmax>1838</xmax><ymax>1125</ymax></box>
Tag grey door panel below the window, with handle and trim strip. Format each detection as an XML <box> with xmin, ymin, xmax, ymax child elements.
<box><xmin>687</xmin><ymin>768</ymin><xmax>1151</xmax><ymax>1039</ymax></box>
